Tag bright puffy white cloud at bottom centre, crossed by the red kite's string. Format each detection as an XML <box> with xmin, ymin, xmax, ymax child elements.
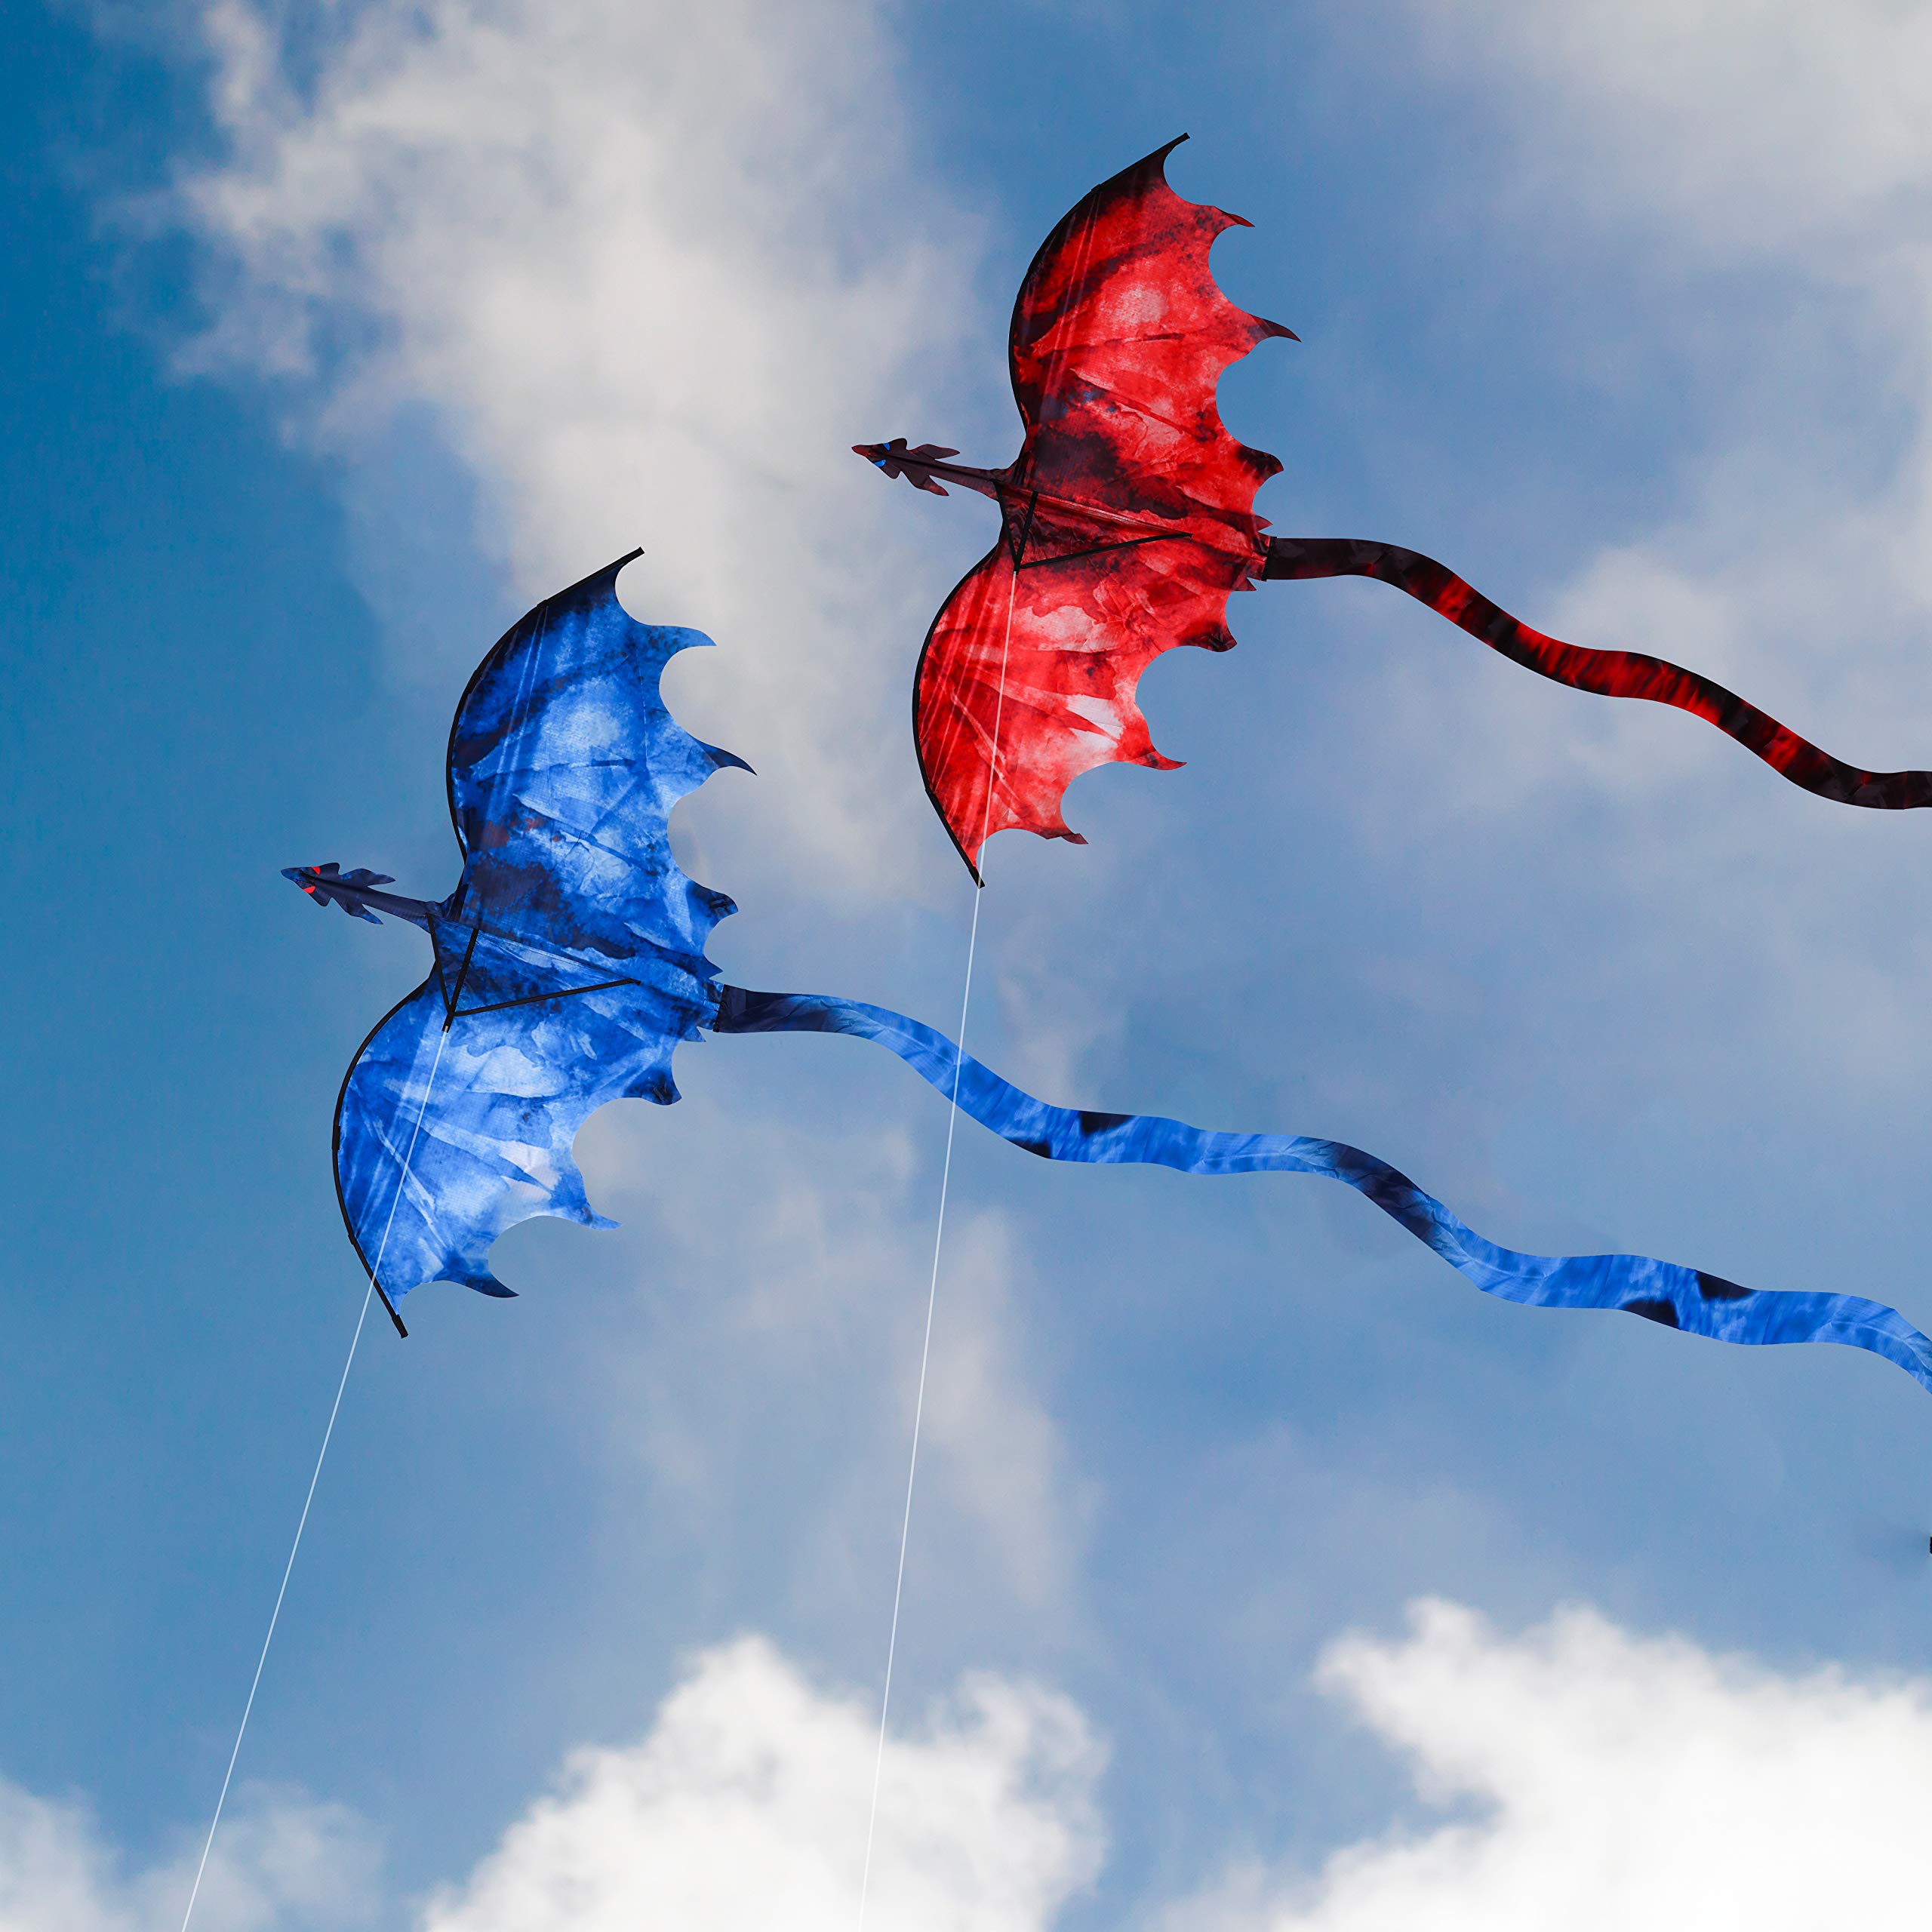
<box><xmin>423</xmin><ymin>1638</ymin><xmax>1101</xmax><ymax>1932</ymax></box>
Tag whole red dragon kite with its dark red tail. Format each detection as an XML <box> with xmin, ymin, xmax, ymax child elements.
<box><xmin>854</xmin><ymin>135</ymin><xmax>1932</xmax><ymax>881</ymax></box>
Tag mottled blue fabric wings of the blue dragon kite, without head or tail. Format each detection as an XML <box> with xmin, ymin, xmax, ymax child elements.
<box><xmin>332</xmin><ymin>556</ymin><xmax>742</xmax><ymax>1302</ymax></box>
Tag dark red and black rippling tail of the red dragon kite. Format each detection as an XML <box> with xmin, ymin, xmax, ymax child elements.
<box><xmin>1262</xmin><ymin>537</ymin><xmax>1932</xmax><ymax>811</ymax></box>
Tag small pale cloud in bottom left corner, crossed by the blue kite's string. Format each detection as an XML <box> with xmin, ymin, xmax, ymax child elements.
<box><xmin>0</xmin><ymin>1783</ymin><xmax>377</xmax><ymax>1932</ymax></box>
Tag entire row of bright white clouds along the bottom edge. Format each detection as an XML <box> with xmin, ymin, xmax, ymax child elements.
<box><xmin>26</xmin><ymin>1601</ymin><xmax>1932</xmax><ymax>1932</ymax></box>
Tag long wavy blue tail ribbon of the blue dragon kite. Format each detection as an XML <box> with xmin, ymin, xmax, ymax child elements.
<box><xmin>715</xmin><ymin>986</ymin><xmax>1932</xmax><ymax>1389</ymax></box>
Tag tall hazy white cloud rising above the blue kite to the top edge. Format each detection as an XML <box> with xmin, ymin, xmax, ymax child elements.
<box><xmin>180</xmin><ymin>0</ymin><xmax>993</xmax><ymax>891</ymax></box>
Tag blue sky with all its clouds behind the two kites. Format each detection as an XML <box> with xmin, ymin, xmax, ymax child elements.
<box><xmin>11</xmin><ymin>0</ymin><xmax>1932</xmax><ymax>1932</ymax></box>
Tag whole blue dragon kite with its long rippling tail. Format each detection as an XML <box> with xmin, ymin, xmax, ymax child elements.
<box><xmin>284</xmin><ymin>551</ymin><xmax>1932</xmax><ymax>1389</ymax></box>
